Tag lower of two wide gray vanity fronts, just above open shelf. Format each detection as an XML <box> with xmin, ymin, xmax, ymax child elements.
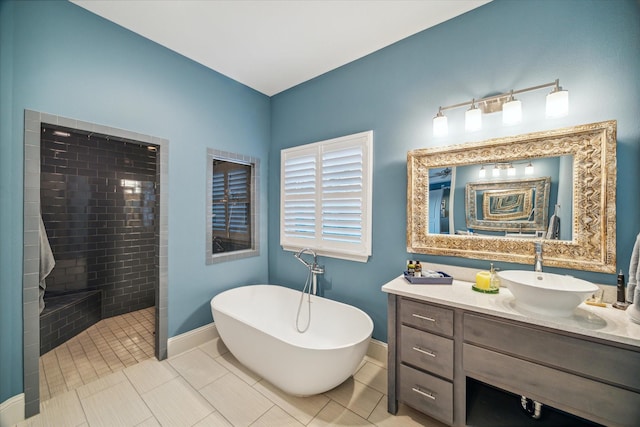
<box><xmin>463</xmin><ymin>344</ymin><xmax>640</xmax><ymax>427</ymax></box>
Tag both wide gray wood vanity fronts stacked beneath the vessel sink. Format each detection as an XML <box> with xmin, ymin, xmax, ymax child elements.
<box><xmin>463</xmin><ymin>313</ymin><xmax>640</xmax><ymax>426</ymax></box>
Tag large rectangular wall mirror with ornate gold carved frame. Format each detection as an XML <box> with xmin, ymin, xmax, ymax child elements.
<box><xmin>407</xmin><ymin>120</ymin><xmax>616</xmax><ymax>273</ymax></box>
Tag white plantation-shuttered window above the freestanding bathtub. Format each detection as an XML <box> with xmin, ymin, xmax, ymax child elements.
<box><xmin>280</xmin><ymin>131</ymin><xmax>373</xmax><ymax>262</ymax></box>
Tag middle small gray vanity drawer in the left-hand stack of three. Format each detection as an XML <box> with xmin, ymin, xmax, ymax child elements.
<box><xmin>400</xmin><ymin>325</ymin><xmax>453</xmax><ymax>379</ymax></box>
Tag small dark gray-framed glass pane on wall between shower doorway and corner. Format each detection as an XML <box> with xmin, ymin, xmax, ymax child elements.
<box><xmin>207</xmin><ymin>150</ymin><xmax>259</xmax><ymax>264</ymax></box>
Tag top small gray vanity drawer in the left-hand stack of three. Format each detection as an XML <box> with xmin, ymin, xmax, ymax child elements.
<box><xmin>400</xmin><ymin>298</ymin><xmax>453</xmax><ymax>336</ymax></box>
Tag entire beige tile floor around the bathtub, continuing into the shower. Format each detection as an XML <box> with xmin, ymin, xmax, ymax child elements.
<box><xmin>25</xmin><ymin>308</ymin><xmax>443</xmax><ymax>427</ymax></box>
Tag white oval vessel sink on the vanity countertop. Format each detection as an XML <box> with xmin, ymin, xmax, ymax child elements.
<box><xmin>498</xmin><ymin>270</ymin><xmax>598</xmax><ymax>317</ymax></box>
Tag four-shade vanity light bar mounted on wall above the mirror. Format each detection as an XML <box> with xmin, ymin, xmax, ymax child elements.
<box><xmin>433</xmin><ymin>79</ymin><xmax>569</xmax><ymax>137</ymax></box>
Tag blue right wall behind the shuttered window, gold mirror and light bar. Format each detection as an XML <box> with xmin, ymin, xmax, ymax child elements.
<box><xmin>269</xmin><ymin>0</ymin><xmax>640</xmax><ymax>341</ymax></box>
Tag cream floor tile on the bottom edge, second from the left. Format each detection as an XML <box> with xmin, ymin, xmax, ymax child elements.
<box><xmin>80</xmin><ymin>381</ymin><xmax>152</xmax><ymax>427</ymax></box>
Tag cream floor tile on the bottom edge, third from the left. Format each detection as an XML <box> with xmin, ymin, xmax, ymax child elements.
<box><xmin>142</xmin><ymin>378</ymin><xmax>214</xmax><ymax>427</ymax></box>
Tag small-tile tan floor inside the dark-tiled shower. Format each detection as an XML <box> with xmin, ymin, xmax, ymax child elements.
<box><xmin>40</xmin><ymin>307</ymin><xmax>155</xmax><ymax>402</ymax></box>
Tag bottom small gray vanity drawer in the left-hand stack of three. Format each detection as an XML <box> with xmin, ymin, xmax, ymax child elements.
<box><xmin>398</xmin><ymin>365</ymin><xmax>453</xmax><ymax>424</ymax></box>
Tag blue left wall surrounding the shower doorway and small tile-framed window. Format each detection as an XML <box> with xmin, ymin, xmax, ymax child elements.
<box><xmin>0</xmin><ymin>1</ymin><xmax>270</xmax><ymax>402</ymax></box>
